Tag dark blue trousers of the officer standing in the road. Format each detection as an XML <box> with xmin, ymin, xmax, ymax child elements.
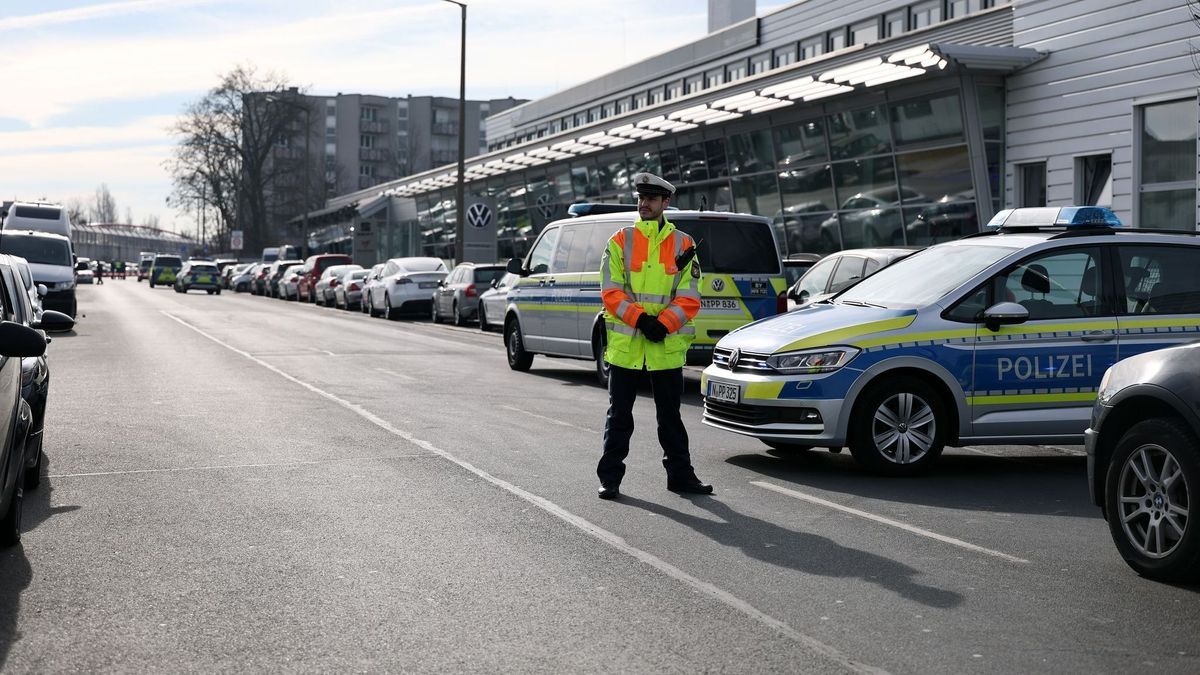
<box><xmin>596</xmin><ymin>365</ymin><xmax>696</xmax><ymax>486</ymax></box>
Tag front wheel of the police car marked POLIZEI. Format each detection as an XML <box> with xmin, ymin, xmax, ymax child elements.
<box><xmin>848</xmin><ymin>377</ymin><xmax>947</xmax><ymax>476</ymax></box>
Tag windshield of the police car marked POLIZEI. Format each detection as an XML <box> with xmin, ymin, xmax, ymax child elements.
<box><xmin>834</xmin><ymin>245</ymin><xmax>1015</xmax><ymax>309</ymax></box>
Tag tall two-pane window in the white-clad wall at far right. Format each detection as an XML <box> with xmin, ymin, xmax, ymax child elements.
<box><xmin>1136</xmin><ymin>98</ymin><xmax>1196</xmax><ymax>229</ymax></box>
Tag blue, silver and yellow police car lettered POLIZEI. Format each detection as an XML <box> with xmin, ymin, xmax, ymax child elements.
<box><xmin>701</xmin><ymin>207</ymin><xmax>1200</xmax><ymax>474</ymax></box>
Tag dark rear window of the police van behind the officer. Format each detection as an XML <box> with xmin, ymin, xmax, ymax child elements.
<box><xmin>667</xmin><ymin>219</ymin><xmax>781</xmax><ymax>274</ymax></box>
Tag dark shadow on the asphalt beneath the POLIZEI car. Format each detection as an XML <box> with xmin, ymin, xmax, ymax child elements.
<box><xmin>725</xmin><ymin>449</ymin><xmax>1102</xmax><ymax>519</ymax></box>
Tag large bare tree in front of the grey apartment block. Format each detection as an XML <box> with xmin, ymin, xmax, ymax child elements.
<box><xmin>167</xmin><ymin>66</ymin><xmax>312</xmax><ymax>250</ymax></box>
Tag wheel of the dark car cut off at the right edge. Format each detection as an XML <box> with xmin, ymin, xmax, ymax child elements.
<box><xmin>1104</xmin><ymin>418</ymin><xmax>1200</xmax><ymax>581</ymax></box>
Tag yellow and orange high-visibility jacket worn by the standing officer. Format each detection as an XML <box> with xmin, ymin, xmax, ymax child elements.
<box><xmin>600</xmin><ymin>217</ymin><xmax>700</xmax><ymax>370</ymax></box>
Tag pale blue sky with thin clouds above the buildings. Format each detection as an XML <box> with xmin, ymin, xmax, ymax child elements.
<box><xmin>0</xmin><ymin>0</ymin><xmax>794</xmax><ymax>232</ymax></box>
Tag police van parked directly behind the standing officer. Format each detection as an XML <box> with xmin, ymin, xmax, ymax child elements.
<box><xmin>504</xmin><ymin>207</ymin><xmax>787</xmax><ymax>384</ymax></box>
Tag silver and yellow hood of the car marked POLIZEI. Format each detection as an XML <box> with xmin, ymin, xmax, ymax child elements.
<box><xmin>716</xmin><ymin>303</ymin><xmax>917</xmax><ymax>354</ymax></box>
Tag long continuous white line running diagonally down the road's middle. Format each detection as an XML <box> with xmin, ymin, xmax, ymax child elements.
<box><xmin>160</xmin><ymin>310</ymin><xmax>886</xmax><ymax>674</ymax></box>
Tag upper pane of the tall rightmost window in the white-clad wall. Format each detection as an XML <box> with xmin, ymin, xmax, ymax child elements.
<box><xmin>1141</xmin><ymin>98</ymin><xmax>1196</xmax><ymax>183</ymax></box>
